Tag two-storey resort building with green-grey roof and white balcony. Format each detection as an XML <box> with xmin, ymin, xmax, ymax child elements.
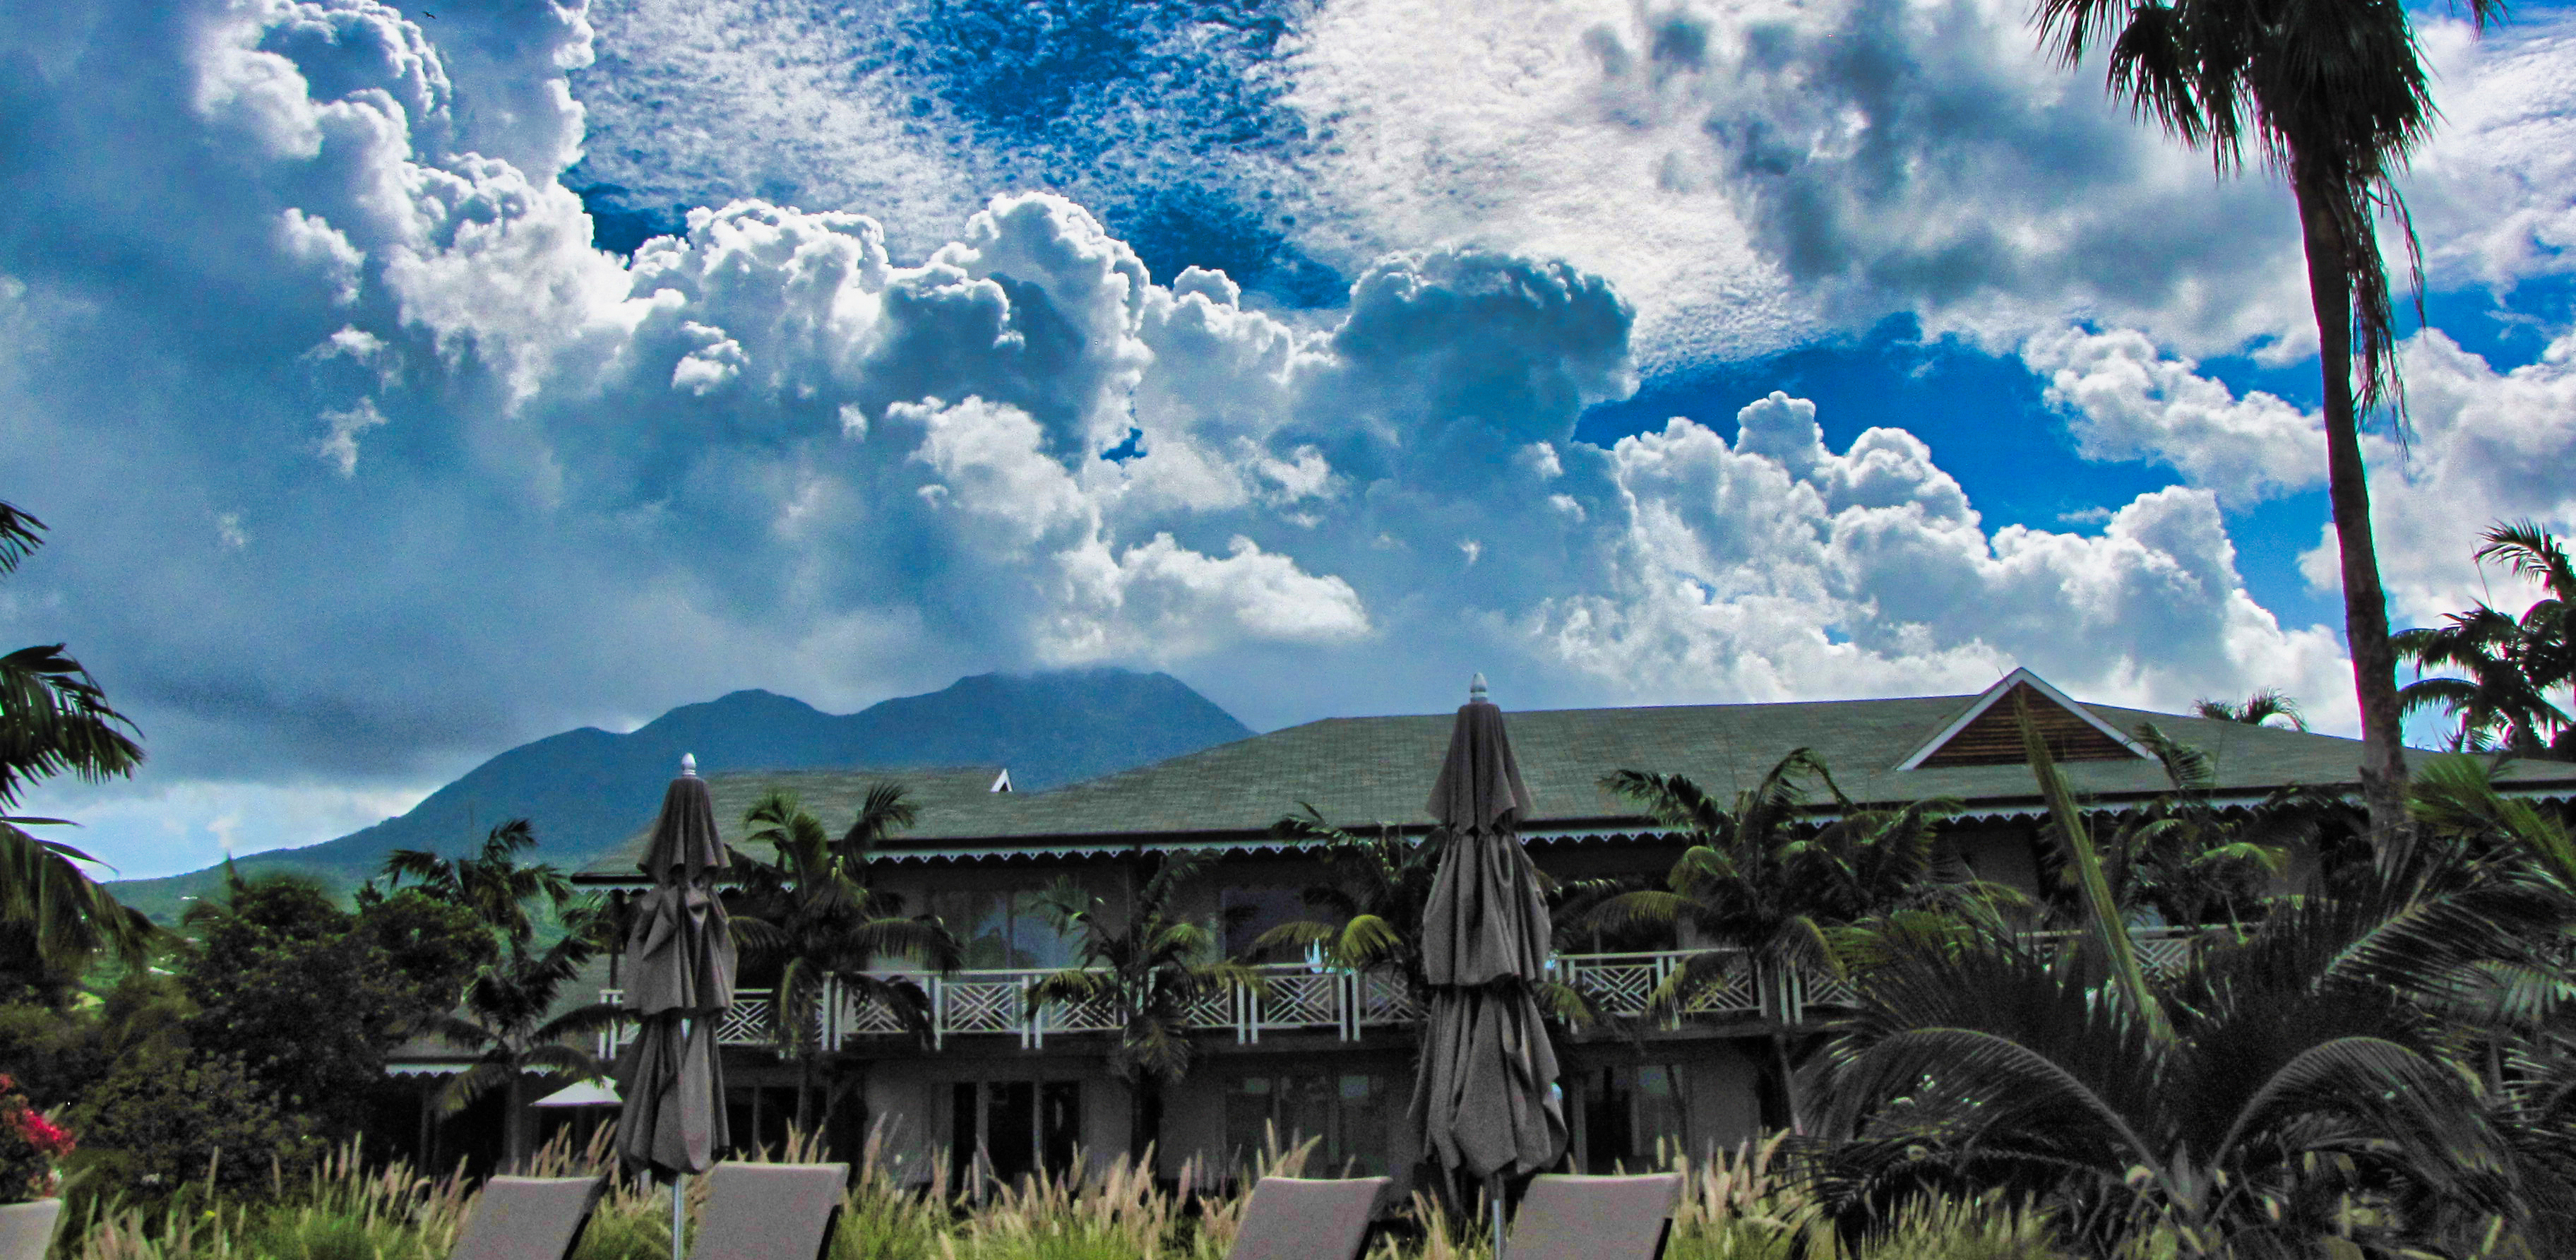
<box><xmin>518</xmin><ymin>670</ymin><xmax>2576</xmax><ymax>1177</ymax></box>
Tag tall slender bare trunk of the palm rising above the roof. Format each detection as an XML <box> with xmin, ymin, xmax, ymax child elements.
<box><xmin>2290</xmin><ymin>160</ymin><xmax>2406</xmax><ymax>843</ymax></box>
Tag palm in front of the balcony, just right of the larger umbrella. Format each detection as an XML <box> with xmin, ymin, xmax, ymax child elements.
<box><xmin>1592</xmin><ymin>747</ymin><xmax>2004</xmax><ymax>1131</ymax></box>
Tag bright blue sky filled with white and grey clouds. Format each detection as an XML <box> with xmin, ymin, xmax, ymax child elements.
<box><xmin>0</xmin><ymin>0</ymin><xmax>2576</xmax><ymax>876</ymax></box>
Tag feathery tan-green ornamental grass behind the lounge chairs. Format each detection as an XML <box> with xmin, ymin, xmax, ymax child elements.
<box><xmin>54</xmin><ymin>1131</ymin><xmax>2066</xmax><ymax>1260</ymax></box>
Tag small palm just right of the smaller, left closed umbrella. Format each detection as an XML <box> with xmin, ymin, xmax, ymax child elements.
<box><xmin>732</xmin><ymin>783</ymin><xmax>958</xmax><ymax>1131</ymax></box>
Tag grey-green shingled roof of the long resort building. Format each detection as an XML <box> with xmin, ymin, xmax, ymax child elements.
<box><xmin>582</xmin><ymin>672</ymin><xmax>2576</xmax><ymax>881</ymax></box>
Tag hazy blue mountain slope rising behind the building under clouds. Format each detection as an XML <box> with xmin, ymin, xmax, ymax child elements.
<box><xmin>114</xmin><ymin>670</ymin><xmax>1252</xmax><ymax>920</ymax></box>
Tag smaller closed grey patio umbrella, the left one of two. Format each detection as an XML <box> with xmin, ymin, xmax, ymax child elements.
<box><xmin>619</xmin><ymin>758</ymin><xmax>734</xmax><ymax>1255</ymax></box>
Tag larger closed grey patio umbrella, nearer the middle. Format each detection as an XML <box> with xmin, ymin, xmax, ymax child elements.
<box><xmin>1412</xmin><ymin>675</ymin><xmax>1566</xmax><ymax>1249</ymax></box>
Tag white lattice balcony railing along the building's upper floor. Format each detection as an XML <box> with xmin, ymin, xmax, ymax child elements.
<box><xmin>600</xmin><ymin>930</ymin><xmax>2198</xmax><ymax>1057</ymax></box>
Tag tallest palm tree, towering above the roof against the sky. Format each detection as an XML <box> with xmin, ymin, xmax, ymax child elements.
<box><xmin>2038</xmin><ymin>0</ymin><xmax>2504</xmax><ymax>835</ymax></box>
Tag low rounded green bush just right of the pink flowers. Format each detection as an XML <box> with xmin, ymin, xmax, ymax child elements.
<box><xmin>72</xmin><ymin>1046</ymin><xmax>325</xmax><ymax>1196</ymax></box>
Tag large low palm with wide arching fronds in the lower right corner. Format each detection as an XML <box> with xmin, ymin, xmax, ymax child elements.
<box><xmin>1818</xmin><ymin>706</ymin><xmax>2576</xmax><ymax>1257</ymax></box>
